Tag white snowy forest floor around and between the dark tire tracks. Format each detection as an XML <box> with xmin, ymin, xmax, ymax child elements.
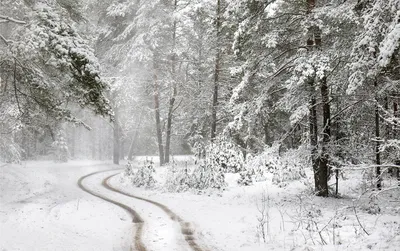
<box><xmin>0</xmin><ymin>158</ymin><xmax>400</xmax><ymax>251</ymax></box>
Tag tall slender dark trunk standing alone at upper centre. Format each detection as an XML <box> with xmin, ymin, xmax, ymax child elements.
<box><xmin>211</xmin><ymin>0</ymin><xmax>221</xmax><ymax>141</ymax></box>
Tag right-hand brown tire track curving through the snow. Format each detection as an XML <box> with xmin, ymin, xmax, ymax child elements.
<box><xmin>102</xmin><ymin>173</ymin><xmax>206</xmax><ymax>251</ymax></box>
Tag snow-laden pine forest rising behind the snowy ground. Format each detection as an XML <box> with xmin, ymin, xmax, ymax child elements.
<box><xmin>0</xmin><ymin>0</ymin><xmax>400</xmax><ymax>250</ymax></box>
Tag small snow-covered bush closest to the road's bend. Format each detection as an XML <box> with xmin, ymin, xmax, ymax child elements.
<box><xmin>125</xmin><ymin>160</ymin><xmax>156</xmax><ymax>188</ymax></box>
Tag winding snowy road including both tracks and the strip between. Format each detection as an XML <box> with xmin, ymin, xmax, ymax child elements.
<box><xmin>78</xmin><ymin>169</ymin><xmax>205</xmax><ymax>251</ymax></box>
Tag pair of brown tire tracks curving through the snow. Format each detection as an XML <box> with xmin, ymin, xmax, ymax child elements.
<box><xmin>78</xmin><ymin>169</ymin><xmax>206</xmax><ymax>251</ymax></box>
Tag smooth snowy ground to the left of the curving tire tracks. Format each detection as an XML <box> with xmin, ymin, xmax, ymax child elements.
<box><xmin>0</xmin><ymin>161</ymin><xmax>132</xmax><ymax>251</ymax></box>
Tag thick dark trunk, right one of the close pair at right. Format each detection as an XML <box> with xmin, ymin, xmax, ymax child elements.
<box><xmin>317</xmin><ymin>77</ymin><xmax>331</xmax><ymax>197</ymax></box>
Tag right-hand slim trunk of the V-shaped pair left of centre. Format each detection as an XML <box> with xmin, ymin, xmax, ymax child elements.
<box><xmin>164</xmin><ymin>0</ymin><xmax>178</xmax><ymax>163</ymax></box>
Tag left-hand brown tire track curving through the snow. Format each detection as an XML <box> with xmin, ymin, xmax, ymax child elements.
<box><xmin>77</xmin><ymin>169</ymin><xmax>146</xmax><ymax>251</ymax></box>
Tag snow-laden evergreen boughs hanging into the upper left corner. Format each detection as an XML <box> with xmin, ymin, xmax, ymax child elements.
<box><xmin>0</xmin><ymin>1</ymin><xmax>112</xmax><ymax>161</ymax></box>
